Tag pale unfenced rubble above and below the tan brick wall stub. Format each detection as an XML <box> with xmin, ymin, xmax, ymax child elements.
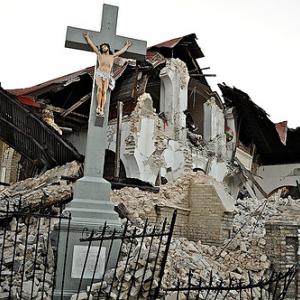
<box><xmin>106</xmin><ymin>182</ymin><xmax>289</xmax><ymax>299</ymax></box>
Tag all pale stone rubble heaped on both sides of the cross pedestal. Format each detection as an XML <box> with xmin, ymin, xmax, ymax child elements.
<box><xmin>0</xmin><ymin>162</ymin><xmax>296</xmax><ymax>299</ymax></box>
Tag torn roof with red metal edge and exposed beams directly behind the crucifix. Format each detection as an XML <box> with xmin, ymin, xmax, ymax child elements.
<box><xmin>9</xmin><ymin>34</ymin><xmax>211</xmax><ymax>130</ymax></box>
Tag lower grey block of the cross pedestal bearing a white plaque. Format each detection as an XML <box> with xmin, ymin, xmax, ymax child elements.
<box><xmin>53</xmin><ymin>222</ymin><xmax>121</xmax><ymax>300</ymax></box>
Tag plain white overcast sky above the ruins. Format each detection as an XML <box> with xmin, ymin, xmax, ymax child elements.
<box><xmin>0</xmin><ymin>0</ymin><xmax>300</xmax><ymax>128</ymax></box>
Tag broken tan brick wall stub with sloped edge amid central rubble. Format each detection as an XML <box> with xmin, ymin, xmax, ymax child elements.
<box><xmin>149</xmin><ymin>183</ymin><xmax>234</xmax><ymax>245</ymax></box>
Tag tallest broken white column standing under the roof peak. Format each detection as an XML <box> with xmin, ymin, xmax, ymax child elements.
<box><xmin>160</xmin><ymin>58</ymin><xmax>191</xmax><ymax>181</ymax></box>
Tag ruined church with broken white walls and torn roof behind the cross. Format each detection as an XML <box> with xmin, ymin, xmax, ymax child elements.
<box><xmin>4</xmin><ymin>34</ymin><xmax>226</xmax><ymax>185</ymax></box>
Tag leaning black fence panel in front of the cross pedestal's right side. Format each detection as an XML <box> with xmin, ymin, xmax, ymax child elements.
<box><xmin>67</xmin><ymin>211</ymin><xmax>176</xmax><ymax>299</ymax></box>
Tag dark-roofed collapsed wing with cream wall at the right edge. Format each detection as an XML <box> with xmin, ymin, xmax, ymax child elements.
<box><xmin>219</xmin><ymin>84</ymin><xmax>300</xmax><ymax>199</ymax></box>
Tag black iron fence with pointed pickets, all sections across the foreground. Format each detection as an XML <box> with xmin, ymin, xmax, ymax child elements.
<box><xmin>0</xmin><ymin>202</ymin><xmax>296</xmax><ymax>300</ymax></box>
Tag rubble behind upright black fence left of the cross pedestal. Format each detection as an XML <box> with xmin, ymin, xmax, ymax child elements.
<box><xmin>0</xmin><ymin>217</ymin><xmax>55</xmax><ymax>300</ymax></box>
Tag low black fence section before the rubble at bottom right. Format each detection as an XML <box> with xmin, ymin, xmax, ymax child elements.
<box><xmin>165</xmin><ymin>265</ymin><xmax>297</xmax><ymax>300</ymax></box>
